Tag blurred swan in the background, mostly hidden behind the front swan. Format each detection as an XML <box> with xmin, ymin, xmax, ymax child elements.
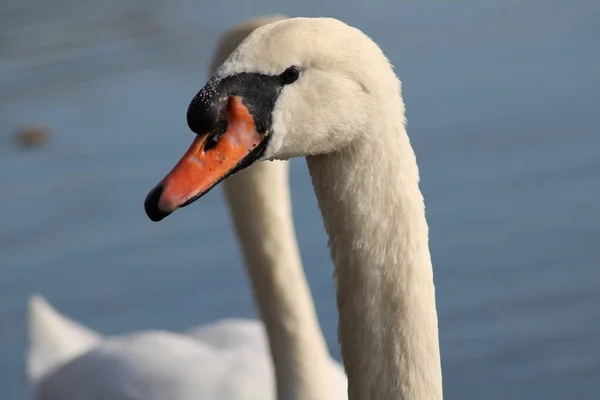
<box><xmin>27</xmin><ymin>15</ymin><xmax>347</xmax><ymax>400</ymax></box>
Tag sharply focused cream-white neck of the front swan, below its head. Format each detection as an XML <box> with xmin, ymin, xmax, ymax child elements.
<box><xmin>307</xmin><ymin>107</ymin><xmax>442</xmax><ymax>400</ymax></box>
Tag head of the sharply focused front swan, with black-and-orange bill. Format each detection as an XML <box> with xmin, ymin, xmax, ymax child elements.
<box><xmin>145</xmin><ymin>18</ymin><xmax>404</xmax><ymax>221</ymax></box>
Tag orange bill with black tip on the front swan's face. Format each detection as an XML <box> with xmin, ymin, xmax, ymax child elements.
<box><xmin>144</xmin><ymin>96</ymin><xmax>266</xmax><ymax>222</ymax></box>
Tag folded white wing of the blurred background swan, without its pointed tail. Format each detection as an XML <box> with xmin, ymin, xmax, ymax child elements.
<box><xmin>37</xmin><ymin>331</ymin><xmax>275</xmax><ymax>400</ymax></box>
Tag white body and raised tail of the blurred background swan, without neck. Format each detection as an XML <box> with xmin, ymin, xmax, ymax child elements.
<box><xmin>28</xmin><ymin>296</ymin><xmax>275</xmax><ymax>400</ymax></box>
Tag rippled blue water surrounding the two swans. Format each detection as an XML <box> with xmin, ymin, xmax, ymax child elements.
<box><xmin>0</xmin><ymin>0</ymin><xmax>600</xmax><ymax>400</ymax></box>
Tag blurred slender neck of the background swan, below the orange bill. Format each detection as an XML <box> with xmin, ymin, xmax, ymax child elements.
<box><xmin>224</xmin><ymin>161</ymin><xmax>340</xmax><ymax>400</ymax></box>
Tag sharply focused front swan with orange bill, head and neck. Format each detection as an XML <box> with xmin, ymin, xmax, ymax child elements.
<box><xmin>144</xmin><ymin>18</ymin><xmax>442</xmax><ymax>400</ymax></box>
